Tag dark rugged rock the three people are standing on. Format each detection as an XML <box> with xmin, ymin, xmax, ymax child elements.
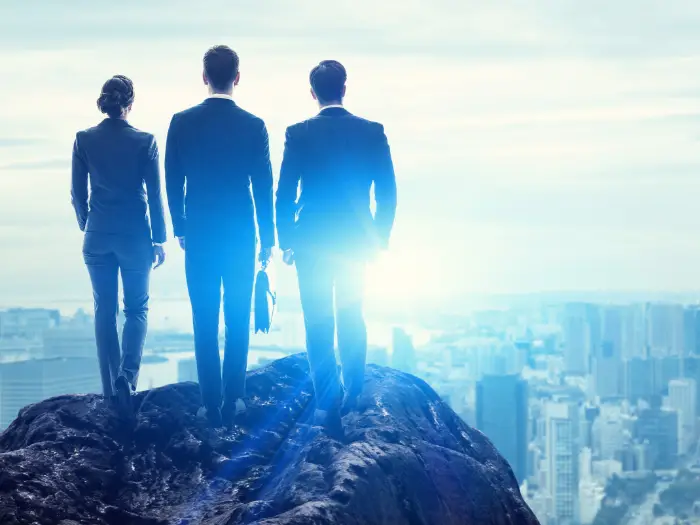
<box><xmin>0</xmin><ymin>355</ymin><xmax>537</xmax><ymax>525</ymax></box>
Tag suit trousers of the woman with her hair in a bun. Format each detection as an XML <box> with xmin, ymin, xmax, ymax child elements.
<box><xmin>83</xmin><ymin>231</ymin><xmax>153</xmax><ymax>396</ymax></box>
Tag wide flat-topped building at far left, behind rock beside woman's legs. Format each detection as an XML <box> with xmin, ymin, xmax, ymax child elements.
<box><xmin>0</xmin><ymin>357</ymin><xmax>102</xmax><ymax>430</ymax></box>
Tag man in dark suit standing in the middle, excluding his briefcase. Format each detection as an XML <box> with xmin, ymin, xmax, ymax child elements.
<box><xmin>165</xmin><ymin>46</ymin><xmax>275</xmax><ymax>426</ymax></box>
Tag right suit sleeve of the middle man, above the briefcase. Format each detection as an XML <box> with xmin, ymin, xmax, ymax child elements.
<box><xmin>250</xmin><ymin>121</ymin><xmax>275</xmax><ymax>248</ymax></box>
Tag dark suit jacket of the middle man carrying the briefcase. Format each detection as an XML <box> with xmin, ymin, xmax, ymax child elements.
<box><xmin>165</xmin><ymin>98</ymin><xmax>275</xmax><ymax>248</ymax></box>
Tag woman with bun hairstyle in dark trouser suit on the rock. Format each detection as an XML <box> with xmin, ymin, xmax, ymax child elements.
<box><xmin>71</xmin><ymin>75</ymin><xmax>166</xmax><ymax>411</ymax></box>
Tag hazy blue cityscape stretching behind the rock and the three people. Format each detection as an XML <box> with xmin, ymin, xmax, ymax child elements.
<box><xmin>0</xmin><ymin>302</ymin><xmax>700</xmax><ymax>525</ymax></box>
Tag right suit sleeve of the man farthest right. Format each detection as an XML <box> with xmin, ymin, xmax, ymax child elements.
<box><xmin>374</xmin><ymin>125</ymin><xmax>397</xmax><ymax>248</ymax></box>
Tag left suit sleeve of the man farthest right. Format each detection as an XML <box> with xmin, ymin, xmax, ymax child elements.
<box><xmin>277</xmin><ymin>128</ymin><xmax>301</xmax><ymax>250</ymax></box>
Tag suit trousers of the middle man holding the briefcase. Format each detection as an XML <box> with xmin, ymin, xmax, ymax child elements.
<box><xmin>185</xmin><ymin>234</ymin><xmax>256</xmax><ymax>409</ymax></box>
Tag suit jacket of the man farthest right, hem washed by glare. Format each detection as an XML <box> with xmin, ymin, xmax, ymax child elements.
<box><xmin>277</xmin><ymin>107</ymin><xmax>396</xmax><ymax>252</ymax></box>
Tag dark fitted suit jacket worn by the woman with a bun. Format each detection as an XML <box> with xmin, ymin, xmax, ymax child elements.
<box><xmin>71</xmin><ymin>118</ymin><xmax>166</xmax><ymax>243</ymax></box>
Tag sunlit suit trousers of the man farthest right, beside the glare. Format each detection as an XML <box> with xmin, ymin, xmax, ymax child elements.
<box><xmin>295</xmin><ymin>250</ymin><xmax>367</xmax><ymax>410</ymax></box>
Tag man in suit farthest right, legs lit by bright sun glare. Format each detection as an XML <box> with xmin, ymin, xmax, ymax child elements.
<box><xmin>277</xmin><ymin>60</ymin><xmax>396</xmax><ymax>429</ymax></box>
